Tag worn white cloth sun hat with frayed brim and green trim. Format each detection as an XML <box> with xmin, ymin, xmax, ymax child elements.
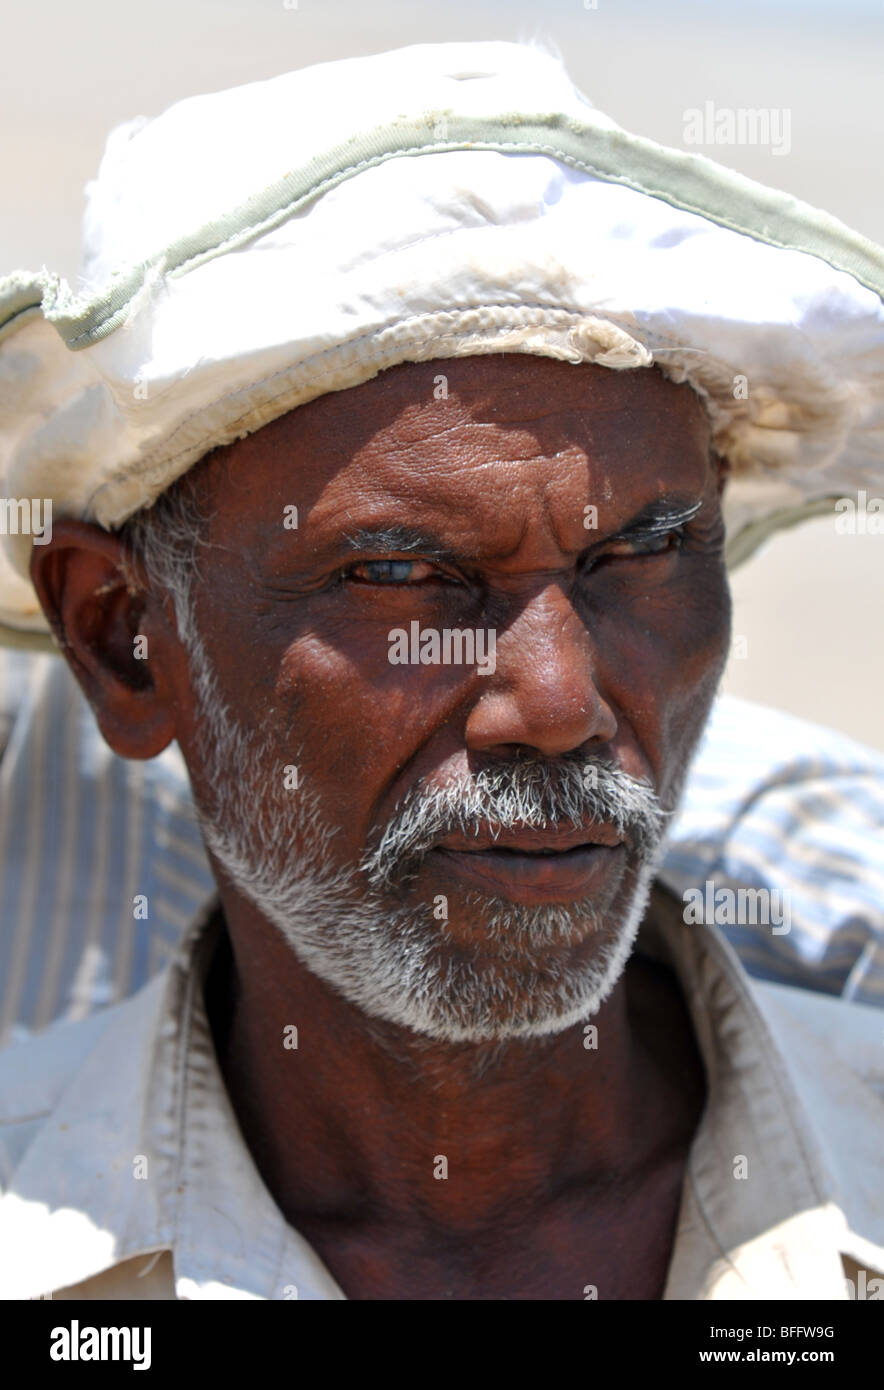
<box><xmin>0</xmin><ymin>43</ymin><xmax>884</xmax><ymax>642</ymax></box>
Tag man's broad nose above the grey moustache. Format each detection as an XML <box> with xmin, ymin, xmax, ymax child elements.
<box><xmin>466</xmin><ymin>584</ymin><xmax>617</xmax><ymax>758</ymax></box>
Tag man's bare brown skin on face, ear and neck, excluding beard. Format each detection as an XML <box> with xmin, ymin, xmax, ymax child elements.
<box><xmin>32</xmin><ymin>354</ymin><xmax>730</xmax><ymax>1300</ymax></box>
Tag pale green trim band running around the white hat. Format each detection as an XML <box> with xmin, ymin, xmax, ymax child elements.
<box><xmin>0</xmin><ymin>111</ymin><xmax>884</xmax><ymax>350</ymax></box>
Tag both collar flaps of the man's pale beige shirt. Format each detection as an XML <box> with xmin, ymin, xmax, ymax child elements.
<box><xmin>0</xmin><ymin>894</ymin><xmax>884</xmax><ymax>1300</ymax></box>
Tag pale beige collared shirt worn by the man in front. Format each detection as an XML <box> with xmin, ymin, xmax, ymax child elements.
<box><xmin>0</xmin><ymin>888</ymin><xmax>884</xmax><ymax>1300</ymax></box>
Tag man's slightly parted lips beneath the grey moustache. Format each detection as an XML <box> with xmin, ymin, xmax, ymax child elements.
<box><xmin>432</xmin><ymin>826</ymin><xmax>625</xmax><ymax>904</ymax></box>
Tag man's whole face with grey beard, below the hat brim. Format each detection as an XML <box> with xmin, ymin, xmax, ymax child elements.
<box><xmin>174</xmin><ymin>354</ymin><xmax>730</xmax><ymax>1040</ymax></box>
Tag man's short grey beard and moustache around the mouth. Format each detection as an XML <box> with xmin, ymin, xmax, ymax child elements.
<box><xmin>188</xmin><ymin>630</ymin><xmax>666</xmax><ymax>1043</ymax></box>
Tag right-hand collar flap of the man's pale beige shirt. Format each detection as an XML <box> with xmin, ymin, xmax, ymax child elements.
<box><xmin>639</xmin><ymin>892</ymin><xmax>861</xmax><ymax>1300</ymax></box>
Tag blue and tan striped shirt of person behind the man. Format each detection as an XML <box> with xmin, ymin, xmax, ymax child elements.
<box><xmin>0</xmin><ymin>652</ymin><xmax>884</xmax><ymax>1045</ymax></box>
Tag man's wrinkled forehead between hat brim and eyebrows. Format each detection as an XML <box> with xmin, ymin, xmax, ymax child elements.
<box><xmin>197</xmin><ymin>354</ymin><xmax>710</xmax><ymax>543</ymax></box>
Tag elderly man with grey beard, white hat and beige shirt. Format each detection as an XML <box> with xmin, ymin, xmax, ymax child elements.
<box><xmin>0</xmin><ymin>44</ymin><xmax>884</xmax><ymax>1300</ymax></box>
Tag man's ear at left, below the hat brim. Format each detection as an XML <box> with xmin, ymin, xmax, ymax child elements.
<box><xmin>31</xmin><ymin>520</ymin><xmax>186</xmax><ymax>758</ymax></box>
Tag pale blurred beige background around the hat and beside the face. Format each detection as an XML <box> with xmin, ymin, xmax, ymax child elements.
<box><xmin>0</xmin><ymin>0</ymin><xmax>884</xmax><ymax>748</ymax></box>
